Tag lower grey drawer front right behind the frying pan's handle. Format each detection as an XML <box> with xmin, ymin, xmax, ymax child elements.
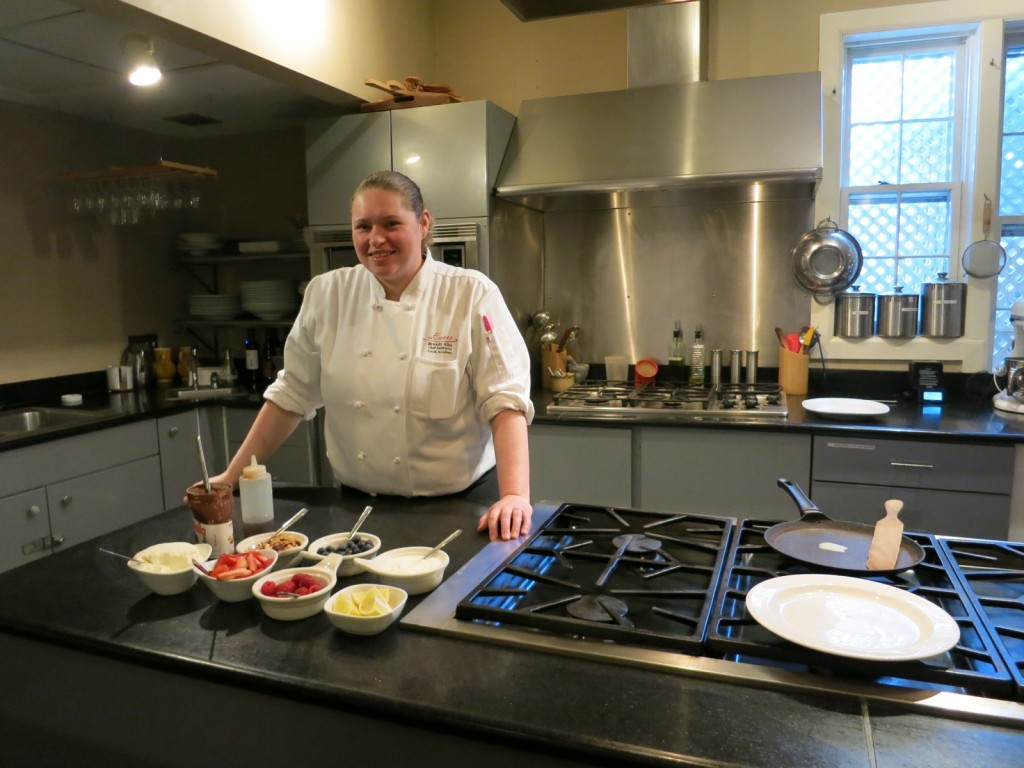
<box><xmin>811</xmin><ymin>480</ymin><xmax>1010</xmax><ymax>540</ymax></box>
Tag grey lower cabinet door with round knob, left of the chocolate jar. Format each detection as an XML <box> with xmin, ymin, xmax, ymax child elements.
<box><xmin>46</xmin><ymin>456</ymin><xmax>163</xmax><ymax>547</ymax></box>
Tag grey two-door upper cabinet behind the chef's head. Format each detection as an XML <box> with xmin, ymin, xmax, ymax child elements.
<box><xmin>306</xmin><ymin>101</ymin><xmax>515</xmax><ymax>226</ymax></box>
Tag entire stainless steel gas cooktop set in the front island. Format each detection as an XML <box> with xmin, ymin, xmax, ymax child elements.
<box><xmin>401</xmin><ymin>502</ymin><xmax>1024</xmax><ymax>727</ymax></box>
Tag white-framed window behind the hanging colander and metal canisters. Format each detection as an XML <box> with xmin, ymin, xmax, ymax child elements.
<box><xmin>812</xmin><ymin>0</ymin><xmax>1024</xmax><ymax>372</ymax></box>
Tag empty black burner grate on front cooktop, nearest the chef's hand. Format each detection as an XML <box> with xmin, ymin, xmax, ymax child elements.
<box><xmin>456</xmin><ymin>504</ymin><xmax>732</xmax><ymax>653</ymax></box>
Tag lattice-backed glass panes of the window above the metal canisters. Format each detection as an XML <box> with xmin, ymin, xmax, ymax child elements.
<box><xmin>845</xmin><ymin>41</ymin><xmax>958</xmax><ymax>293</ymax></box>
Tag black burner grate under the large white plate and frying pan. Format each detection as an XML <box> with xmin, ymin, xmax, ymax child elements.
<box><xmin>707</xmin><ymin>520</ymin><xmax>1013</xmax><ymax>697</ymax></box>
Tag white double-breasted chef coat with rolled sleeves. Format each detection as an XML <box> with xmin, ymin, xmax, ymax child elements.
<box><xmin>264</xmin><ymin>249</ymin><xmax>534</xmax><ymax>497</ymax></box>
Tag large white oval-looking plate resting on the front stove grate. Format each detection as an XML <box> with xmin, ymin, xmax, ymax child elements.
<box><xmin>746</xmin><ymin>573</ymin><xmax>959</xmax><ymax>662</ymax></box>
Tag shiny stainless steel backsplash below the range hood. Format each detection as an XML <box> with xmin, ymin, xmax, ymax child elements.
<box><xmin>492</xmin><ymin>193</ymin><xmax>813</xmax><ymax>367</ymax></box>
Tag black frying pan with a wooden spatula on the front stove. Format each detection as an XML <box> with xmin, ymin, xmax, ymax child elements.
<box><xmin>765</xmin><ymin>477</ymin><xmax>925</xmax><ymax>575</ymax></box>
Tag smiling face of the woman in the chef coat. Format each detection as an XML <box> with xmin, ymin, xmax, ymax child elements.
<box><xmin>352</xmin><ymin>187</ymin><xmax>430</xmax><ymax>301</ymax></box>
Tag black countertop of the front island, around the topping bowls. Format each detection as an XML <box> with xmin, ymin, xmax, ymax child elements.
<box><xmin>0</xmin><ymin>484</ymin><xmax>1024</xmax><ymax>768</ymax></box>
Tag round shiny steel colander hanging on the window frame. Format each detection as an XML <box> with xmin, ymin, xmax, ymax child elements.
<box><xmin>792</xmin><ymin>217</ymin><xmax>864</xmax><ymax>303</ymax></box>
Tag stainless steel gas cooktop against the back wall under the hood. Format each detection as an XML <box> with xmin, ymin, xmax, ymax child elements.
<box><xmin>547</xmin><ymin>381</ymin><xmax>790</xmax><ymax>421</ymax></box>
